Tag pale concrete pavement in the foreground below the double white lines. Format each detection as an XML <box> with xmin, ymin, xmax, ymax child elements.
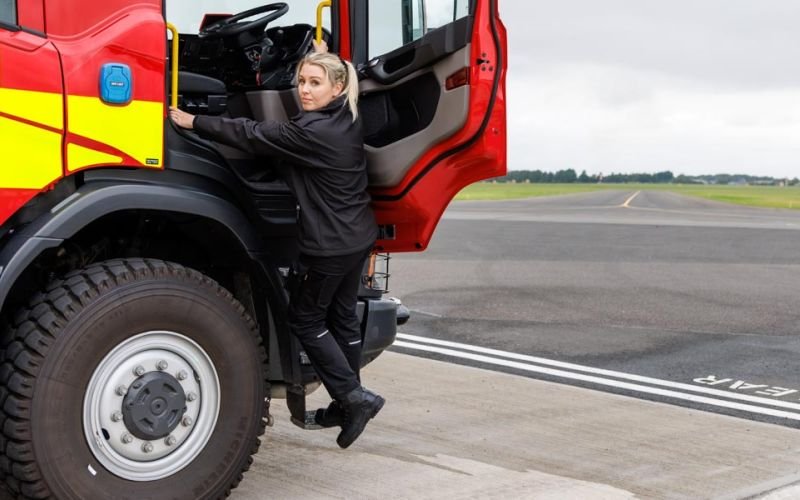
<box><xmin>231</xmin><ymin>352</ymin><xmax>800</xmax><ymax>500</ymax></box>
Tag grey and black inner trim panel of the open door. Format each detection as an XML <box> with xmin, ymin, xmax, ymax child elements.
<box><xmin>359</xmin><ymin>45</ymin><xmax>470</xmax><ymax>187</ymax></box>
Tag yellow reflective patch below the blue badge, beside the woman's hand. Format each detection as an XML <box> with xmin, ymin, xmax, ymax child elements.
<box><xmin>67</xmin><ymin>96</ymin><xmax>164</xmax><ymax>168</ymax></box>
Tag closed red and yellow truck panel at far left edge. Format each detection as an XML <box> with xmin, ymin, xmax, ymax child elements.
<box><xmin>0</xmin><ymin>0</ymin><xmax>64</xmax><ymax>223</ymax></box>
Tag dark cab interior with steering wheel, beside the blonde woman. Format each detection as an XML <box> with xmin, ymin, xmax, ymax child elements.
<box><xmin>167</xmin><ymin>3</ymin><xmax>330</xmax><ymax>189</ymax></box>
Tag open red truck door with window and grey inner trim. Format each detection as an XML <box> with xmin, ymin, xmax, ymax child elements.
<box><xmin>343</xmin><ymin>0</ymin><xmax>506</xmax><ymax>252</ymax></box>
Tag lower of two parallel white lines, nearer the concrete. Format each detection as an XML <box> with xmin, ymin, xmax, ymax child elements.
<box><xmin>394</xmin><ymin>340</ymin><xmax>800</xmax><ymax>421</ymax></box>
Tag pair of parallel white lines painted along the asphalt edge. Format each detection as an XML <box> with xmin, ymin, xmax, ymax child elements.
<box><xmin>394</xmin><ymin>333</ymin><xmax>800</xmax><ymax>421</ymax></box>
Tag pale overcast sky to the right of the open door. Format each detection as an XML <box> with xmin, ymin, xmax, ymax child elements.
<box><xmin>500</xmin><ymin>0</ymin><xmax>800</xmax><ymax>177</ymax></box>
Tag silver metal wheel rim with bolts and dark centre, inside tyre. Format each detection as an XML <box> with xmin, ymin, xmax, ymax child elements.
<box><xmin>83</xmin><ymin>330</ymin><xmax>220</xmax><ymax>481</ymax></box>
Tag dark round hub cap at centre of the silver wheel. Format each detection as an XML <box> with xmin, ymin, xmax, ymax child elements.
<box><xmin>122</xmin><ymin>371</ymin><xmax>186</xmax><ymax>440</ymax></box>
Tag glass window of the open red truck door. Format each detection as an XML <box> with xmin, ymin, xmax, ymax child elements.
<box><xmin>367</xmin><ymin>0</ymin><xmax>470</xmax><ymax>59</ymax></box>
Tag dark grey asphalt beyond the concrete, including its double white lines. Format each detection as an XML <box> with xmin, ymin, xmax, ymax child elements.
<box><xmin>390</xmin><ymin>190</ymin><xmax>800</xmax><ymax>427</ymax></box>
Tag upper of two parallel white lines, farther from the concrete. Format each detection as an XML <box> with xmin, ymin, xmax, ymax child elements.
<box><xmin>395</xmin><ymin>333</ymin><xmax>800</xmax><ymax>411</ymax></box>
